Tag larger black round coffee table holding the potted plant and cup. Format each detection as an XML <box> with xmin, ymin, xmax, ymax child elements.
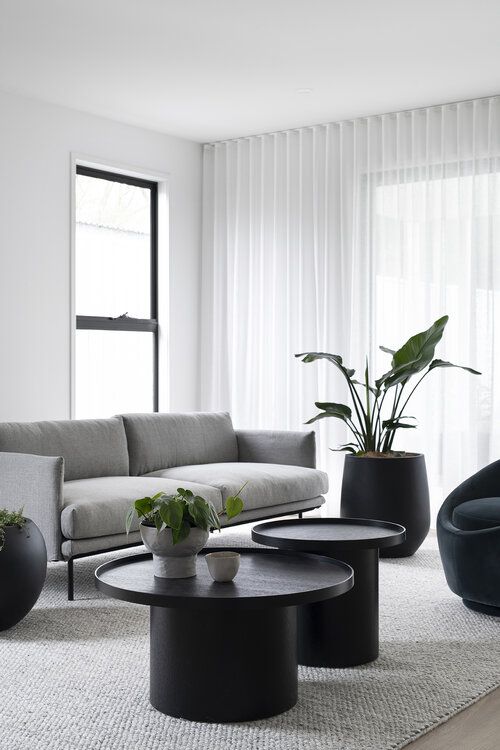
<box><xmin>95</xmin><ymin>547</ymin><xmax>353</xmax><ymax>722</ymax></box>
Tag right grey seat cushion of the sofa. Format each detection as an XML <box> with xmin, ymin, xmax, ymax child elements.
<box><xmin>148</xmin><ymin>461</ymin><xmax>328</xmax><ymax>510</ymax></box>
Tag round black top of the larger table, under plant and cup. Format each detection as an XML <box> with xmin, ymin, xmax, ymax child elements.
<box><xmin>95</xmin><ymin>547</ymin><xmax>354</xmax><ymax>609</ymax></box>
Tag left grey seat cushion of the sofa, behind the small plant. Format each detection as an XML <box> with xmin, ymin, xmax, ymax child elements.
<box><xmin>61</xmin><ymin>477</ymin><xmax>222</xmax><ymax>539</ymax></box>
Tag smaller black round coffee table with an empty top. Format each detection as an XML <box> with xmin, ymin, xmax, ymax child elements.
<box><xmin>252</xmin><ymin>518</ymin><xmax>406</xmax><ymax>667</ymax></box>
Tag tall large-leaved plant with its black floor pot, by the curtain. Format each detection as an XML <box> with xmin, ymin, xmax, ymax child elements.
<box><xmin>296</xmin><ymin>315</ymin><xmax>481</xmax><ymax>557</ymax></box>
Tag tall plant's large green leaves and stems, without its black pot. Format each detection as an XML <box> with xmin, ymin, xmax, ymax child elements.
<box><xmin>295</xmin><ymin>315</ymin><xmax>481</xmax><ymax>456</ymax></box>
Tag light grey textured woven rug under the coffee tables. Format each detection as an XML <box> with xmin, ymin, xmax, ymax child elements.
<box><xmin>0</xmin><ymin>529</ymin><xmax>500</xmax><ymax>750</ymax></box>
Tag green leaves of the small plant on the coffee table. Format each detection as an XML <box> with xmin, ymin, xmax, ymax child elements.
<box><xmin>125</xmin><ymin>482</ymin><xmax>247</xmax><ymax>544</ymax></box>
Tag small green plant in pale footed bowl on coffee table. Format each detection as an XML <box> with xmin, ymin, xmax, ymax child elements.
<box><xmin>125</xmin><ymin>485</ymin><xmax>245</xmax><ymax>578</ymax></box>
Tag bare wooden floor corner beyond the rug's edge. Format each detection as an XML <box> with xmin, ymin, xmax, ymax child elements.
<box><xmin>408</xmin><ymin>688</ymin><xmax>500</xmax><ymax>750</ymax></box>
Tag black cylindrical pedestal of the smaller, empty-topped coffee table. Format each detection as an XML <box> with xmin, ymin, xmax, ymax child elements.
<box><xmin>298</xmin><ymin>549</ymin><xmax>379</xmax><ymax>667</ymax></box>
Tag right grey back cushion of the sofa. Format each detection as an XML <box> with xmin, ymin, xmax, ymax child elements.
<box><xmin>122</xmin><ymin>412</ymin><xmax>238</xmax><ymax>476</ymax></box>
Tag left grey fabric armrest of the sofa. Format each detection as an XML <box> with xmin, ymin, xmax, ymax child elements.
<box><xmin>0</xmin><ymin>452</ymin><xmax>64</xmax><ymax>560</ymax></box>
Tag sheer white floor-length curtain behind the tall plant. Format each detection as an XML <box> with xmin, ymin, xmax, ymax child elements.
<box><xmin>201</xmin><ymin>97</ymin><xmax>500</xmax><ymax>524</ymax></box>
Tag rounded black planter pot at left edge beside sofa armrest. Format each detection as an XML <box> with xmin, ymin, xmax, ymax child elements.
<box><xmin>0</xmin><ymin>518</ymin><xmax>47</xmax><ymax>630</ymax></box>
